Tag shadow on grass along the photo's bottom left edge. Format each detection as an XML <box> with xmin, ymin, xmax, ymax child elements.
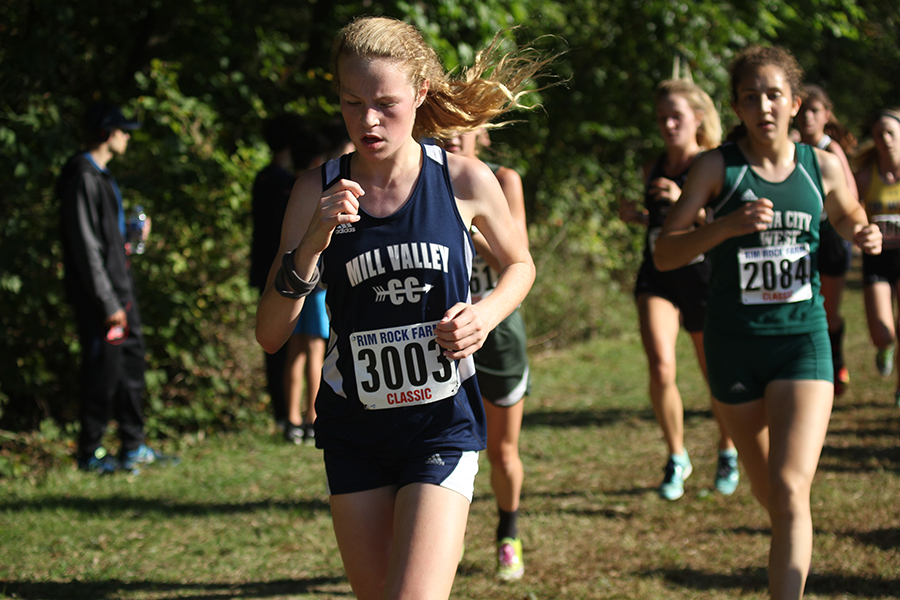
<box><xmin>0</xmin><ymin>577</ymin><xmax>353</xmax><ymax>600</ymax></box>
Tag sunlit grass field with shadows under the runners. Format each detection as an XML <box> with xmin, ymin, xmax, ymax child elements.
<box><xmin>0</xmin><ymin>268</ymin><xmax>900</xmax><ymax>600</ymax></box>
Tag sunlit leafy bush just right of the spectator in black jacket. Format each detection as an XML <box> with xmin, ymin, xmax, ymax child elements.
<box><xmin>123</xmin><ymin>60</ymin><xmax>268</xmax><ymax>434</ymax></box>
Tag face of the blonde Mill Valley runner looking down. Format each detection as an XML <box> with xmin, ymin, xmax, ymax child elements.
<box><xmin>338</xmin><ymin>56</ymin><xmax>427</xmax><ymax>158</ymax></box>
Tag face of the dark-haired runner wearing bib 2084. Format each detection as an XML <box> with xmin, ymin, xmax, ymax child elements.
<box><xmin>732</xmin><ymin>65</ymin><xmax>800</xmax><ymax>143</ymax></box>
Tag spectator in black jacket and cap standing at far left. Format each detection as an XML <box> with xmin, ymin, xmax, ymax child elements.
<box><xmin>57</xmin><ymin>103</ymin><xmax>175</xmax><ymax>474</ymax></box>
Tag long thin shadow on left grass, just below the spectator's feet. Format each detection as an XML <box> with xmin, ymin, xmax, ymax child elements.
<box><xmin>0</xmin><ymin>496</ymin><xmax>330</xmax><ymax>516</ymax></box>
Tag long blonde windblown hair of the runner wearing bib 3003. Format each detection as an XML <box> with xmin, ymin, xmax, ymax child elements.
<box><xmin>331</xmin><ymin>17</ymin><xmax>555</xmax><ymax>139</ymax></box>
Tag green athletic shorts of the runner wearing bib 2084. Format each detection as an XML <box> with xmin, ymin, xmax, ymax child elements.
<box><xmin>703</xmin><ymin>328</ymin><xmax>834</xmax><ymax>404</ymax></box>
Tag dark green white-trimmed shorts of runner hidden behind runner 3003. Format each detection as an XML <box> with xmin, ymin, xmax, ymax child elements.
<box><xmin>475</xmin><ymin>310</ymin><xmax>531</xmax><ymax>406</ymax></box>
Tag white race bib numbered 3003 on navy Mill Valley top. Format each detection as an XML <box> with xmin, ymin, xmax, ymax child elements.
<box><xmin>350</xmin><ymin>321</ymin><xmax>460</xmax><ymax>410</ymax></box>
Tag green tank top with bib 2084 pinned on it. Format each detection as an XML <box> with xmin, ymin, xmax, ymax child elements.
<box><xmin>706</xmin><ymin>143</ymin><xmax>827</xmax><ymax>335</ymax></box>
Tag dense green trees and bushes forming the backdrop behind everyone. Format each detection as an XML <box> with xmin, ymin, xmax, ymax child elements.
<box><xmin>0</xmin><ymin>0</ymin><xmax>900</xmax><ymax>435</ymax></box>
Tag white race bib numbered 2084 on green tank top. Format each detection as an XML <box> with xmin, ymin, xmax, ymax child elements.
<box><xmin>738</xmin><ymin>244</ymin><xmax>812</xmax><ymax>304</ymax></box>
